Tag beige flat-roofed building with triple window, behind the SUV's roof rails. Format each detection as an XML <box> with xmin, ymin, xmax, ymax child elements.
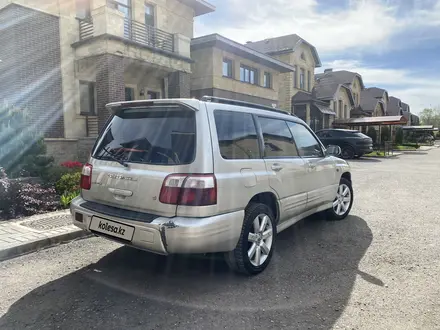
<box><xmin>191</xmin><ymin>34</ymin><xmax>294</xmax><ymax>107</ymax></box>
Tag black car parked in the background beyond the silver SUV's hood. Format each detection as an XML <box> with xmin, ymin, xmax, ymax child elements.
<box><xmin>316</xmin><ymin>129</ymin><xmax>373</xmax><ymax>159</ymax></box>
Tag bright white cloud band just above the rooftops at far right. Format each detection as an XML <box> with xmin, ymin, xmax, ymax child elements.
<box><xmin>319</xmin><ymin>60</ymin><xmax>440</xmax><ymax>113</ymax></box>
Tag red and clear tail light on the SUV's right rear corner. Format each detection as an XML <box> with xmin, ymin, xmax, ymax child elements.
<box><xmin>159</xmin><ymin>174</ymin><xmax>217</xmax><ymax>206</ymax></box>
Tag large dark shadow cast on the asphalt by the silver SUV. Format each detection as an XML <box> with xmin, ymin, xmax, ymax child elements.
<box><xmin>0</xmin><ymin>215</ymin><xmax>374</xmax><ymax>329</ymax></box>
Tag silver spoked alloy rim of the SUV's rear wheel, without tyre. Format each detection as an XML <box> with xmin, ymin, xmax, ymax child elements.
<box><xmin>248</xmin><ymin>214</ymin><xmax>273</xmax><ymax>267</ymax></box>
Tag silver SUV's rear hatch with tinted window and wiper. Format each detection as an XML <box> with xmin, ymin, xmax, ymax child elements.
<box><xmin>82</xmin><ymin>102</ymin><xmax>208</xmax><ymax>217</ymax></box>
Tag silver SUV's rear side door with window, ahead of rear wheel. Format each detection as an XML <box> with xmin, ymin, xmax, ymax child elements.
<box><xmin>258</xmin><ymin>117</ymin><xmax>307</xmax><ymax>223</ymax></box>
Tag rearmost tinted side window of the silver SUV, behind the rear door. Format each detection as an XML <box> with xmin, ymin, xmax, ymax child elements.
<box><xmin>214</xmin><ymin>110</ymin><xmax>260</xmax><ymax>159</ymax></box>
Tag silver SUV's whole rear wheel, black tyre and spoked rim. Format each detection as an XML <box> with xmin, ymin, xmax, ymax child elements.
<box><xmin>225</xmin><ymin>203</ymin><xmax>277</xmax><ymax>275</ymax></box>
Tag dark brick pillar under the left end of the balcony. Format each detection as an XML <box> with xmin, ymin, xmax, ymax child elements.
<box><xmin>96</xmin><ymin>54</ymin><xmax>125</xmax><ymax>130</ymax></box>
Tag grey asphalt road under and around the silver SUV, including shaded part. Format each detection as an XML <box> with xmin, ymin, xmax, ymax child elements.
<box><xmin>0</xmin><ymin>149</ymin><xmax>440</xmax><ymax>329</ymax></box>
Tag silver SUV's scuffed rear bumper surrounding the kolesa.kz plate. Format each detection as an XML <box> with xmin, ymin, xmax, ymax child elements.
<box><xmin>70</xmin><ymin>197</ymin><xmax>244</xmax><ymax>254</ymax></box>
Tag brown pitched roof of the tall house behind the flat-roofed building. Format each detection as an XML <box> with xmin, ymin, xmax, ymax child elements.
<box><xmin>246</xmin><ymin>34</ymin><xmax>321</xmax><ymax>67</ymax></box>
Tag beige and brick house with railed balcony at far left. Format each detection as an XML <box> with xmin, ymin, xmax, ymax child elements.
<box><xmin>0</xmin><ymin>0</ymin><xmax>215</xmax><ymax>158</ymax></box>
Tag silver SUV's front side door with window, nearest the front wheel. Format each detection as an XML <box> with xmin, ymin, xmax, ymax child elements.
<box><xmin>288</xmin><ymin>122</ymin><xmax>338</xmax><ymax>210</ymax></box>
